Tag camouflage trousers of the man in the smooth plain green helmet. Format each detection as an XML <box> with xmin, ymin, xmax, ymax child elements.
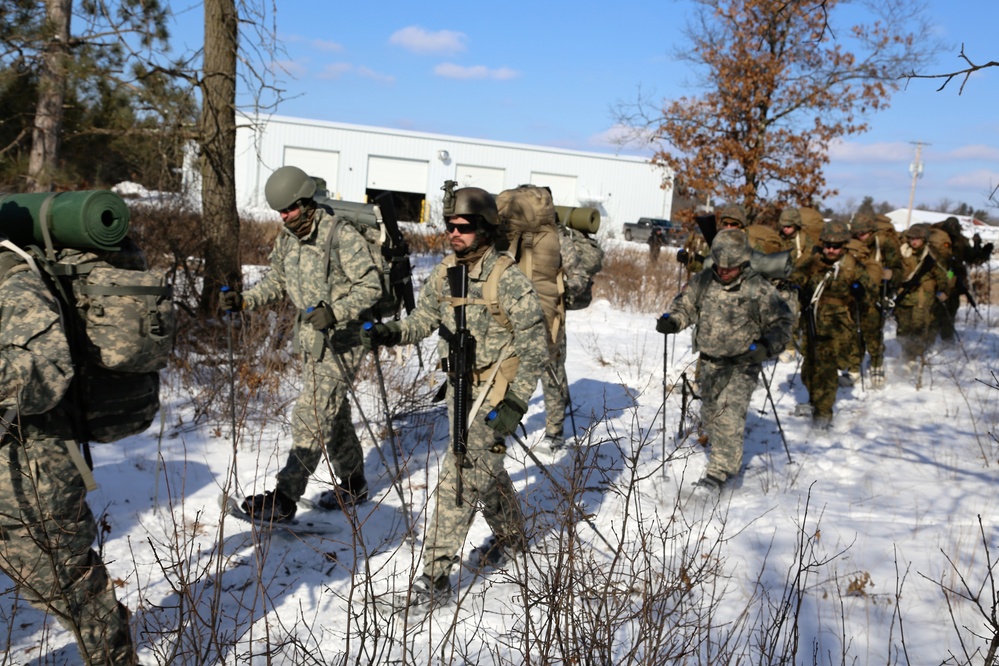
<box><xmin>277</xmin><ymin>347</ymin><xmax>364</xmax><ymax>500</ymax></box>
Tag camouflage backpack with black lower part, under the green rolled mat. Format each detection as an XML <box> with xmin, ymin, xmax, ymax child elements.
<box><xmin>0</xmin><ymin>239</ymin><xmax>176</xmax><ymax>443</ymax></box>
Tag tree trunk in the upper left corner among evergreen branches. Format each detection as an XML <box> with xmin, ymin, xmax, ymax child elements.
<box><xmin>27</xmin><ymin>0</ymin><xmax>73</xmax><ymax>192</ymax></box>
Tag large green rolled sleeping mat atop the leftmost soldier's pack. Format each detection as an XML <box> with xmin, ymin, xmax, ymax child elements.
<box><xmin>0</xmin><ymin>190</ymin><xmax>129</xmax><ymax>251</ymax></box>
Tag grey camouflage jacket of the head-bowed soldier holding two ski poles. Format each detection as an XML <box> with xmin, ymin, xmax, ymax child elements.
<box><xmin>669</xmin><ymin>268</ymin><xmax>793</xmax><ymax>358</ymax></box>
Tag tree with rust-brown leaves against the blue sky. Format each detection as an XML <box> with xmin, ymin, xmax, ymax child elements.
<box><xmin>617</xmin><ymin>0</ymin><xmax>934</xmax><ymax>215</ymax></box>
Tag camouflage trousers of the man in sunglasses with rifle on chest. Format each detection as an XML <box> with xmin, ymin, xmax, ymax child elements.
<box><xmin>423</xmin><ymin>386</ymin><xmax>526</xmax><ymax>579</ymax></box>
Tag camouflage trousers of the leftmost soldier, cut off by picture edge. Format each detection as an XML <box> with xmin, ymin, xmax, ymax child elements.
<box><xmin>0</xmin><ymin>439</ymin><xmax>136</xmax><ymax>666</ymax></box>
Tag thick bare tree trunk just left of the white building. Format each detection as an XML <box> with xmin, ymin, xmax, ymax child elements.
<box><xmin>199</xmin><ymin>0</ymin><xmax>242</xmax><ymax>314</ymax></box>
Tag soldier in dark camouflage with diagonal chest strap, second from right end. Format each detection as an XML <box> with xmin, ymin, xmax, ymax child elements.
<box><xmin>895</xmin><ymin>223</ymin><xmax>947</xmax><ymax>370</ymax></box>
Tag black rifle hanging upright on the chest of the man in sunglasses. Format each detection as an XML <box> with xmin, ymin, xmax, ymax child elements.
<box><xmin>440</xmin><ymin>264</ymin><xmax>475</xmax><ymax>506</ymax></box>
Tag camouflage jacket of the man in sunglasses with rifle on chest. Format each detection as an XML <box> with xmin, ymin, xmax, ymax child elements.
<box><xmin>400</xmin><ymin>245</ymin><xmax>550</xmax><ymax>402</ymax></box>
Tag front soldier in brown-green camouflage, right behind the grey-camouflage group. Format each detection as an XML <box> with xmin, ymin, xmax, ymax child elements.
<box><xmin>792</xmin><ymin>221</ymin><xmax>874</xmax><ymax>429</ymax></box>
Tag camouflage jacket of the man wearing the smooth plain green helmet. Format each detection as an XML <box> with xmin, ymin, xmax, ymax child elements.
<box><xmin>243</xmin><ymin>207</ymin><xmax>382</xmax><ymax>356</ymax></box>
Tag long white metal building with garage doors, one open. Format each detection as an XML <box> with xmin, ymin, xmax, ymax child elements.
<box><xmin>230</xmin><ymin>116</ymin><xmax>672</xmax><ymax>234</ymax></box>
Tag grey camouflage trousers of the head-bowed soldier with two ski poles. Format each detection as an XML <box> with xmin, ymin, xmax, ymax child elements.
<box><xmin>700</xmin><ymin>354</ymin><xmax>760</xmax><ymax>480</ymax></box>
